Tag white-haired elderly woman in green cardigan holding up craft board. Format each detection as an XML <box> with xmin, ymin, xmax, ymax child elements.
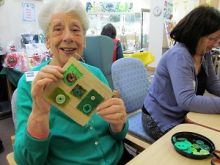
<box><xmin>14</xmin><ymin>0</ymin><xmax>132</xmax><ymax>165</ymax></box>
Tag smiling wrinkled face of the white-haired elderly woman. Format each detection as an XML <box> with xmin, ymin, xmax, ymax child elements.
<box><xmin>46</xmin><ymin>13</ymin><xmax>85</xmax><ymax>67</ymax></box>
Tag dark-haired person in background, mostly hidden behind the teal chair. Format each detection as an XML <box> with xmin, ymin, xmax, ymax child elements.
<box><xmin>101</xmin><ymin>23</ymin><xmax>123</xmax><ymax>62</ymax></box>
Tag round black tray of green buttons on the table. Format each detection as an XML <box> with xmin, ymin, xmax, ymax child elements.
<box><xmin>171</xmin><ymin>132</ymin><xmax>215</xmax><ymax>159</ymax></box>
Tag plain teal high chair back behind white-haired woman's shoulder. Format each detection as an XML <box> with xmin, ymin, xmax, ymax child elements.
<box><xmin>83</xmin><ymin>35</ymin><xmax>114</xmax><ymax>88</ymax></box>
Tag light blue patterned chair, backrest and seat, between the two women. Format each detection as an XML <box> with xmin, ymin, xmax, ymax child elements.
<box><xmin>111</xmin><ymin>58</ymin><xmax>154</xmax><ymax>151</ymax></box>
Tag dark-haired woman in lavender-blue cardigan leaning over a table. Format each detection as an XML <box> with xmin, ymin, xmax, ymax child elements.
<box><xmin>142</xmin><ymin>6</ymin><xmax>220</xmax><ymax>139</ymax></box>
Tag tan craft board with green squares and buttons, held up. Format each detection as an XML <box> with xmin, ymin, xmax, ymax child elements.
<box><xmin>44</xmin><ymin>57</ymin><xmax>113</xmax><ymax>126</ymax></box>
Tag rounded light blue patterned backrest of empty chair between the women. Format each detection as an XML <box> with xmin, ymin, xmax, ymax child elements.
<box><xmin>111</xmin><ymin>58</ymin><xmax>149</xmax><ymax>112</ymax></box>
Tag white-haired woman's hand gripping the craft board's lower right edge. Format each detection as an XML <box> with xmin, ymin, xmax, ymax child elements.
<box><xmin>97</xmin><ymin>98</ymin><xmax>127</xmax><ymax>133</ymax></box>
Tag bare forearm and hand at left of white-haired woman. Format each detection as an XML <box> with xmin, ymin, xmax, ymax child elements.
<box><xmin>27</xmin><ymin>65</ymin><xmax>64</xmax><ymax>139</ymax></box>
